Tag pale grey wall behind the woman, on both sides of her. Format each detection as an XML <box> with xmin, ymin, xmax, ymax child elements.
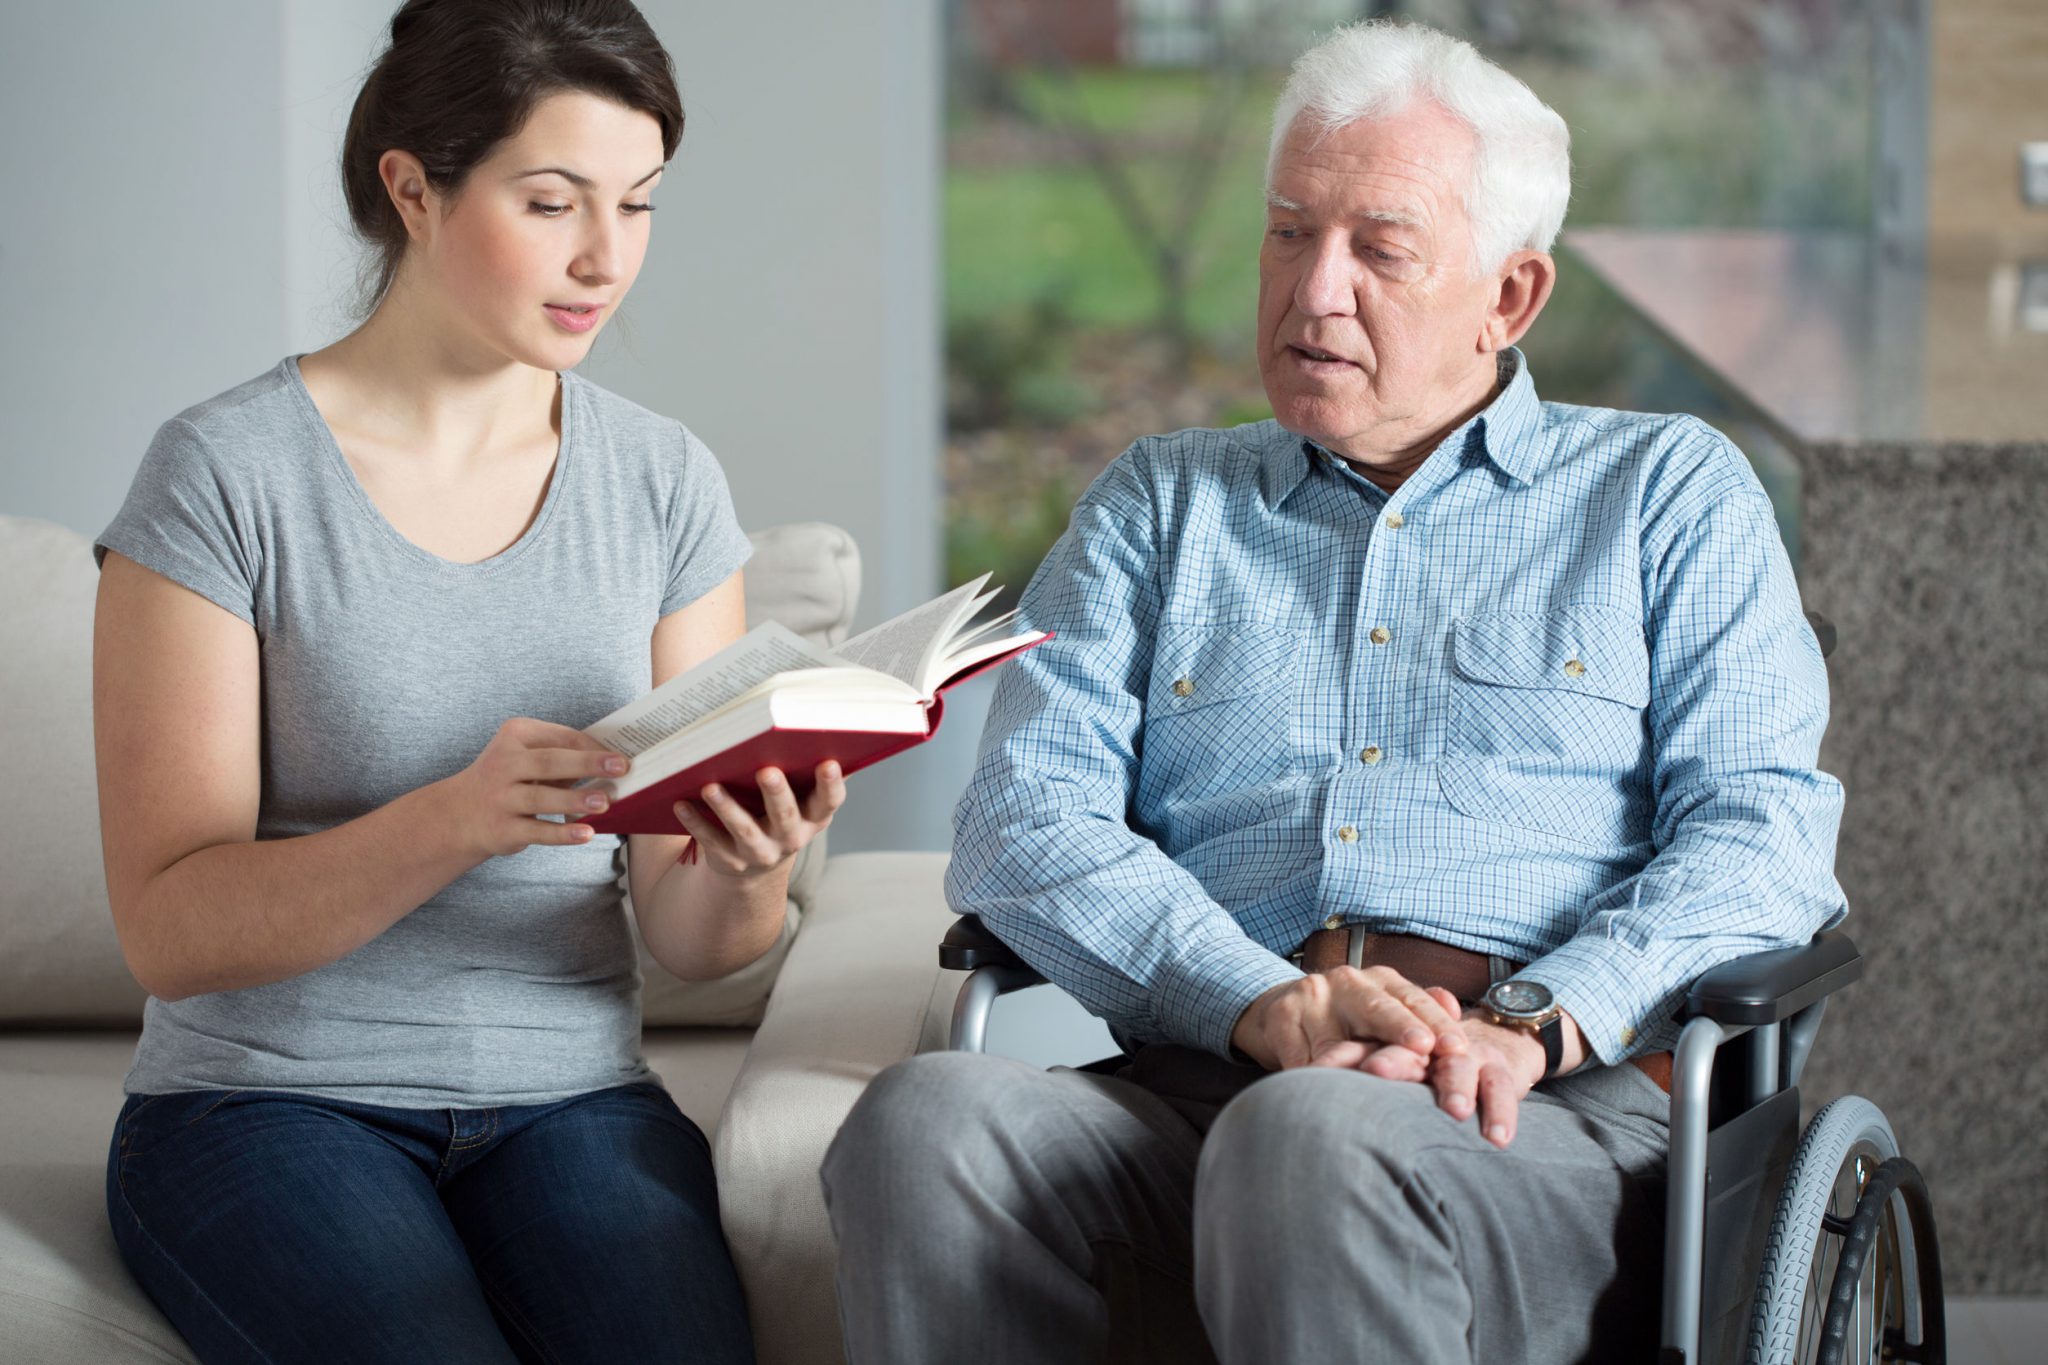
<box><xmin>0</xmin><ymin>0</ymin><xmax>958</xmax><ymax>847</ymax></box>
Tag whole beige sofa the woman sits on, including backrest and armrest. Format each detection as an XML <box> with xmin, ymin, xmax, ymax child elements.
<box><xmin>0</xmin><ymin>516</ymin><xmax>958</xmax><ymax>1365</ymax></box>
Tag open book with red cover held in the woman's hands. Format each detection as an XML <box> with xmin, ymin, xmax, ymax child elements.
<box><xmin>575</xmin><ymin>573</ymin><xmax>1051</xmax><ymax>835</ymax></box>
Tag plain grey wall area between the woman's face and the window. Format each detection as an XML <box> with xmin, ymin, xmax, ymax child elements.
<box><xmin>584</xmin><ymin>0</ymin><xmax>942</xmax><ymax>622</ymax></box>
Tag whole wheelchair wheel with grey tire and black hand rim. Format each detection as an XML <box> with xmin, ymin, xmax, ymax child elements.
<box><xmin>1747</xmin><ymin>1095</ymin><xmax>1946</xmax><ymax>1365</ymax></box>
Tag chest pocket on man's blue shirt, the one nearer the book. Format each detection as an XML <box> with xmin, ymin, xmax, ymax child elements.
<box><xmin>1141</xmin><ymin>622</ymin><xmax>1298</xmax><ymax>800</ymax></box>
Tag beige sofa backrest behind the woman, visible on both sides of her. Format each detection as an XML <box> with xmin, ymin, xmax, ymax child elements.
<box><xmin>0</xmin><ymin>516</ymin><xmax>860</xmax><ymax>1027</ymax></box>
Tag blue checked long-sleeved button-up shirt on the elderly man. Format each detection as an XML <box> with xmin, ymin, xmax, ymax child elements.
<box><xmin>946</xmin><ymin>350</ymin><xmax>1845</xmax><ymax>1062</ymax></box>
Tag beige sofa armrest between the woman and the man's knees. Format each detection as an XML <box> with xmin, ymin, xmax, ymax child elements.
<box><xmin>713</xmin><ymin>853</ymin><xmax>963</xmax><ymax>1365</ymax></box>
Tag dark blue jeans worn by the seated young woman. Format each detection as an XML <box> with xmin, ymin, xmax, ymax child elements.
<box><xmin>106</xmin><ymin>1083</ymin><xmax>754</xmax><ymax>1365</ymax></box>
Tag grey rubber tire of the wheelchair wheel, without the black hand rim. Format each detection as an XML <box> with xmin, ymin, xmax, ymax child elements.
<box><xmin>1745</xmin><ymin>1095</ymin><xmax>1939</xmax><ymax>1365</ymax></box>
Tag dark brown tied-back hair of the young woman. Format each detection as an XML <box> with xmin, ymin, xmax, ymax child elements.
<box><xmin>342</xmin><ymin>0</ymin><xmax>682</xmax><ymax>317</ymax></box>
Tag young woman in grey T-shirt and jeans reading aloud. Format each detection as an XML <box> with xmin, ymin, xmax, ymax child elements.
<box><xmin>94</xmin><ymin>0</ymin><xmax>844</xmax><ymax>1363</ymax></box>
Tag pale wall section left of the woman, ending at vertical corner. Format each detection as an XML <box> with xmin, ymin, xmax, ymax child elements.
<box><xmin>0</xmin><ymin>0</ymin><xmax>285</xmax><ymax>534</ymax></box>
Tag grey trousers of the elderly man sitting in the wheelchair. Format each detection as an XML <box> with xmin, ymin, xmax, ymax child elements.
<box><xmin>821</xmin><ymin>1046</ymin><xmax>1669</xmax><ymax>1365</ymax></box>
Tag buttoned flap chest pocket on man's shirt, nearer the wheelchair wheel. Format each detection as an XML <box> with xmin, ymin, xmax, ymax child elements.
<box><xmin>1440</xmin><ymin>608</ymin><xmax>1651</xmax><ymax>847</ymax></box>
